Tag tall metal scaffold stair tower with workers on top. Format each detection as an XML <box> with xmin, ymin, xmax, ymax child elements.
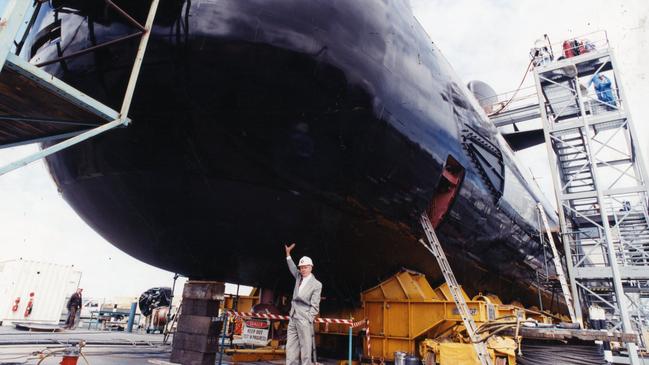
<box><xmin>492</xmin><ymin>32</ymin><xmax>649</xmax><ymax>364</ymax></box>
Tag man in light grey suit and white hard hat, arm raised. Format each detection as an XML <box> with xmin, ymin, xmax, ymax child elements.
<box><xmin>284</xmin><ymin>243</ymin><xmax>322</xmax><ymax>365</ymax></box>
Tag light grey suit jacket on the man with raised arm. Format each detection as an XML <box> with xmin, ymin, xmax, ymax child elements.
<box><xmin>286</xmin><ymin>257</ymin><xmax>322</xmax><ymax>323</ymax></box>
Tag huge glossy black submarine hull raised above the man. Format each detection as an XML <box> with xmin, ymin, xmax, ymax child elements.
<box><xmin>29</xmin><ymin>0</ymin><xmax>558</xmax><ymax>307</ymax></box>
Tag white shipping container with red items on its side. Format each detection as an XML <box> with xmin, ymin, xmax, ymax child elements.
<box><xmin>0</xmin><ymin>260</ymin><xmax>81</xmax><ymax>326</ymax></box>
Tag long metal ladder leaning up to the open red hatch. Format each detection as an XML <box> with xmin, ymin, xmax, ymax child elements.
<box><xmin>420</xmin><ymin>213</ymin><xmax>492</xmax><ymax>365</ymax></box>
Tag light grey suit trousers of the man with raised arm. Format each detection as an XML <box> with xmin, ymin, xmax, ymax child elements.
<box><xmin>286</xmin><ymin>318</ymin><xmax>315</xmax><ymax>365</ymax></box>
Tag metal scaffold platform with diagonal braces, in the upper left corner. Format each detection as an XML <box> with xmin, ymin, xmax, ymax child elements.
<box><xmin>0</xmin><ymin>0</ymin><xmax>159</xmax><ymax>176</ymax></box>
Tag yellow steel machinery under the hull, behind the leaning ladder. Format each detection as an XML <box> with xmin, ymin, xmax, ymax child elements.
<box><xmin>320</xmin><ymin>270</ymin><xmax>551</xmax><ymax>365</ymax></box>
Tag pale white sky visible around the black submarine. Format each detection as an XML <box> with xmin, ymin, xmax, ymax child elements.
<box><xmin>0</xmin><ymin>0</ymin><xmax>649</xmax><ymax>297</ymax></box>
